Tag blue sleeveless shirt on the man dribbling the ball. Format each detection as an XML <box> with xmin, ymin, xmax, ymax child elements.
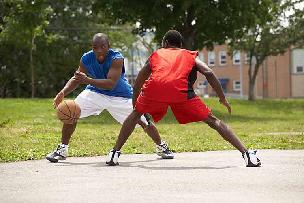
<box><xmin>81</xmin><ymin>49</ymin><xmax>133</xmax><ymax>98</ymax></box>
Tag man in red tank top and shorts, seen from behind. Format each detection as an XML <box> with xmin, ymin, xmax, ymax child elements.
<box><xmin>107</xmin><ymin>30</ymin><xmax>261</xmax><ymax>167</ymax></box>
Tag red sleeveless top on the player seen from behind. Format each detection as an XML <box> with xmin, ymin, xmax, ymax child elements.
<box><xmin>142</xmin><ymin>48</ymin><xmax>198</xmax><ymax>102</ymax></box>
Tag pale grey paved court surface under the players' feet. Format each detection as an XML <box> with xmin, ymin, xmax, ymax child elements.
<box><xmin>0</xmin><ymin>150</ymin><xmax>304</xmax><ymax>203</ymax></box>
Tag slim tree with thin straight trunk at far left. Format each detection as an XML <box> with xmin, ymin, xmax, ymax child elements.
<box><xmin>0</xmin><ymin>0</ymin><xmax>51</xmax><ymax>97</ymax></box>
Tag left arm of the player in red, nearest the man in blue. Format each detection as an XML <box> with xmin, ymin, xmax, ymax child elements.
<box><xmin>132</xmin><ymin>60</ymin><xmax>152</xmax><ymax>107</ymax></box>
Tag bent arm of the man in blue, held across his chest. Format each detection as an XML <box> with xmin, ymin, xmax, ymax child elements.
<box><xmin>75</xmin><ymin>59</ymin><xmax>123</xmax><ymax>90</ymax></box>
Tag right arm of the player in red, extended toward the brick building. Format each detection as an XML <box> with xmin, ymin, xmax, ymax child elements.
<box><xmin>195</xmin><ymin>57</ymin><xmax>231</xmax><ymax>113</ymax></box>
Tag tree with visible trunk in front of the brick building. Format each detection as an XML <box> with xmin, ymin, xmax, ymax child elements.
<box><xmin>230</xmin><ymin>0</ymin><xmax>304</xmax><ymax>101</ymax></box>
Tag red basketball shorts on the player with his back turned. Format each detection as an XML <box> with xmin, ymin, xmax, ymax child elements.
<box><xmin>135</xmin><ymin>95</ymin><xmax>211</xmax><ymax>124</ymax></box>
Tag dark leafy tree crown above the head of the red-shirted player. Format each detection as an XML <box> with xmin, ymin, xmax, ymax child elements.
<box><xmin>93</xmin><ymin>0</ymin><xmax>270</xmax><ymax>49</ymax></box>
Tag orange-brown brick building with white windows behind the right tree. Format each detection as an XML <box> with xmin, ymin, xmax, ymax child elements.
<box><xmin>195</xmin><ymin>45</ymin><xmax>304</xmax><ymax>98</ymax></box>
